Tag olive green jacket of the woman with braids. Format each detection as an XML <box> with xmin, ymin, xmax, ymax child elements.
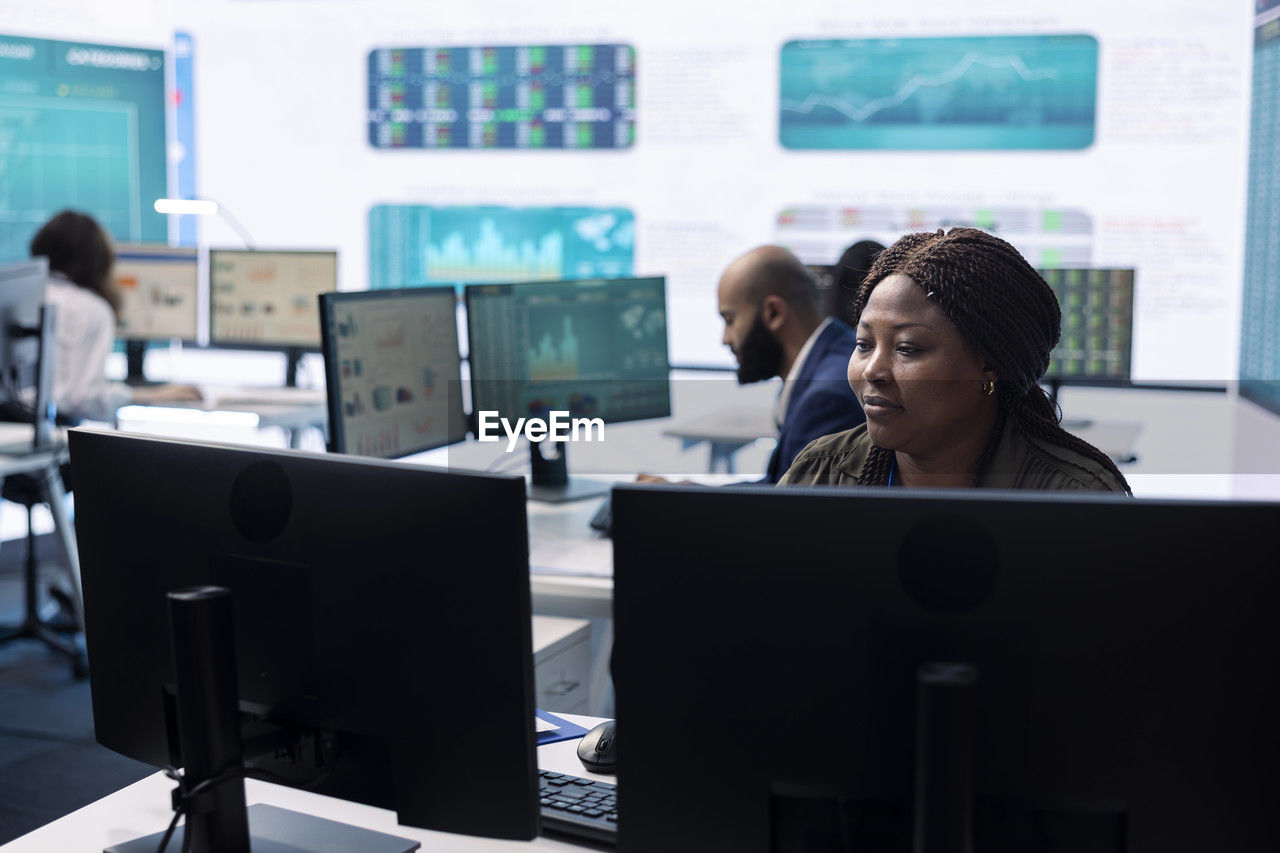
<box><xmin>778</xmin><ymin>421</ymin><xmax>1126</xmax><ymax>492</ymax></box>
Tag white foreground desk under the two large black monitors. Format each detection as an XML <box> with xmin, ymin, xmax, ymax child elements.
<box><xmin>0</xmin><ymin>715</ymin><xmax>616</xmax><ymax>853</ymax></box>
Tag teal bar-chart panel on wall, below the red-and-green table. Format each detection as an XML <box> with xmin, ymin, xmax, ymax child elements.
<box><xmin>369</xmin><ymin>205</ymin><xmax>635</xmax><ymax>288</ymax></box>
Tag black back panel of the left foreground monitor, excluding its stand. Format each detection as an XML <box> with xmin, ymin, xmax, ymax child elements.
<box><xmin>70</xmin><ymin>430</ymin><xmax>538</xmax><ymax>849</ymax></box>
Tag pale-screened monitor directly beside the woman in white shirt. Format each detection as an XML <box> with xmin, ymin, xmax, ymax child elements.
<box><xmin>111</xmin><ymin>243</ymin><xmax>200</xmax><ymax>342</ymax></box>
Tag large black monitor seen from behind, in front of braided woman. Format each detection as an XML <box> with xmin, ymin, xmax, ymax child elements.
<box><xmin>613</xmin><ymin>487</ymin><xmax>1280</xmax><ymax>853</ymax></box>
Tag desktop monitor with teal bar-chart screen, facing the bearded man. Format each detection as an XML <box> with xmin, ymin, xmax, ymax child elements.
<box><xmin>466</xmin><ymin>278</ymin><xmax>671</xmax><ymax>502</ymax></box>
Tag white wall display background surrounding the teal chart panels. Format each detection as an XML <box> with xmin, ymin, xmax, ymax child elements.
<box><xmin>157</xmin><ymin>0</ymin><xmax>1252</xmax><ymax>371</ymax></box>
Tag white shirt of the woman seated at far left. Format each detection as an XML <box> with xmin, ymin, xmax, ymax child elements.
<box><xmin>45</xmin><ymin>273</ymin><xmax>133</xmax><ymax>420</ymax></box>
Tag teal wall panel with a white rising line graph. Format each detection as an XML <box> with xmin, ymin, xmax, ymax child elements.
<box><xmin>778</xmin><ymin>35</ymin><xmax>1098</xmax><ymax>151</ymax></box>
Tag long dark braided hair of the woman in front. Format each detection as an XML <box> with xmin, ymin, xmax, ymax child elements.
<box><xmin>850</xmin><ymin>228</ymin><xmax>1129</xmax><ymax>492</ymax></box>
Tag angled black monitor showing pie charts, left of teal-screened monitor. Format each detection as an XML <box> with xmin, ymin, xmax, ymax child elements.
<box><xmin>320</xmin><ymin>287</ymin><xmax>467</xmax><ymax>459</ymax></box>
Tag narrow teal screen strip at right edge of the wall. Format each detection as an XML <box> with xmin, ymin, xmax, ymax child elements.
<box><xmin>1240</xmin><ymin>8</ymin><xmax>1280</xmax><ymax>414</ymax></box>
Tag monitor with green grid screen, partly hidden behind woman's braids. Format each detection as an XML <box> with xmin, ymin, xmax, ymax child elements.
<box><xmin>1038</xmin><ymin>269</ymin><xmax>1134</xmax><ymax>384</ymax></box>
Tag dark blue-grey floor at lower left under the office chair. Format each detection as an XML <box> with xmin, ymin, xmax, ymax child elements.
<box><xmin>0</xmin><ymin>537</ymin><xmax>154</xmax><ymax>844</ymax></box>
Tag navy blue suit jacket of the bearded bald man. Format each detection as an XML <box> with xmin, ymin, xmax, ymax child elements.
<box><xmin>767</xmin><ymin>320</ymin><xmax>867</xmax><ymax>483</ymax></box>
